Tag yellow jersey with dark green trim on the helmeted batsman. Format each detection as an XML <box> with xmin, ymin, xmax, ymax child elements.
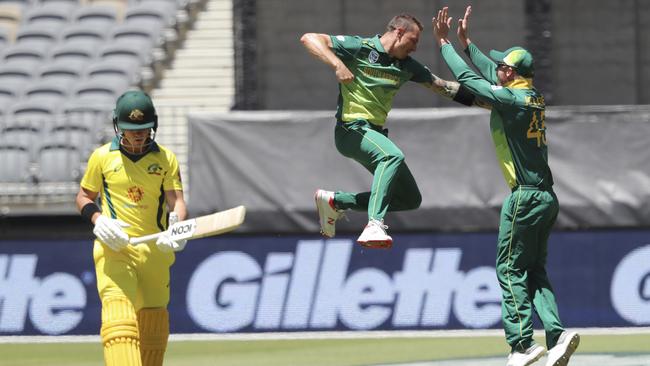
<box><xmin>81</xmin><ymin>137</ymin><xmax>183</xmax><ymax>236</ymax></box>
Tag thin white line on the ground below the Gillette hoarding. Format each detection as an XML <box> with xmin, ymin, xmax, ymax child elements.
<box><xmin>0</xmin><ymin>327</ymin><xmax>650</xmax><ymax>343</ymax></box>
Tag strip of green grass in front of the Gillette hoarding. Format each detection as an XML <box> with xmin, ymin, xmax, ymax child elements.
<box><xmin>0</xmin><ymin>334</ymin><xmax>650</xmax><ymax>366</ymax></box>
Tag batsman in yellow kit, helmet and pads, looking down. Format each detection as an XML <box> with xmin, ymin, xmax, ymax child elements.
<box><xmin>76</xmin><ymin>91</ymin><xmax>187</xmax><ymax>366</ymax></box>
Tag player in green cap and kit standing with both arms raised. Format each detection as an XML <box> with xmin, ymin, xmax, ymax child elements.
<box><xmin>433</xmin><ymin>6</ymin><xmax>580</xmax><ymax>366</ymax></box>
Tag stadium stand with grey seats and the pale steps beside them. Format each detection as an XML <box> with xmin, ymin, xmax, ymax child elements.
<box><xmin>0</xmin><ymin>0</ymin><xmax>232</xmax><ymax>207</ymax></box>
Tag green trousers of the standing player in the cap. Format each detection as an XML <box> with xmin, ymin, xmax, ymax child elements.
<box><xmin>497</xmin><ymin>186</ymin><xmax>564</xmax><ymax>352</ymax></box>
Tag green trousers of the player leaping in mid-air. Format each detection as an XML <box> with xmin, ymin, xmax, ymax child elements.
<box><xmin>334</xmin><ymin>120</ymin><xmax>422</xmax><ymax>220</ymax></box>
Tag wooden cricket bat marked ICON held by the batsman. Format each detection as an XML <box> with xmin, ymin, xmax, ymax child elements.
<box><xmin>129</xmin><ymin>206</ymin><xmax>246</xmax><ymax>245</ymax></box>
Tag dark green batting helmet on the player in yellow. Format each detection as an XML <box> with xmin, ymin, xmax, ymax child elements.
<box><xmin>113</xmin><ymin>90</ymin><xmax>158</xmax><ymax>130</ymax></box>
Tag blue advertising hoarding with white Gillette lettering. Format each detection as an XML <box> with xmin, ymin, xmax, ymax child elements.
<box><xmin>0</xmin><ymin>230</ymin><xmax>650</xmax><ymax>335</ymax></box>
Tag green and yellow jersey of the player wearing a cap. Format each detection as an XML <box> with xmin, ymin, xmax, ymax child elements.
<box><xmin>440</xmin><ymin>44</ymin><xmax>553</xmax><ymax>188</ymax></box>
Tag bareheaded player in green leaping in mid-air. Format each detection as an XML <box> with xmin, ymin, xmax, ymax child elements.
<box><xmin>301</xmin><ymin>14</ymin><xmax>474</xmax><ymax>248</ymax></box>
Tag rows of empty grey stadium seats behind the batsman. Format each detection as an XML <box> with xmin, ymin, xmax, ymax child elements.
<box><xmin>0</xmin><ymin>0</ymin><xmax>203</xmax><ymax>194</ymax></box>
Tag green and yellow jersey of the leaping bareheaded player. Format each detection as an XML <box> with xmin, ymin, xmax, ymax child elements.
<box><xmin>330</xmin><ymin>35</ymin><xmax>433</xmax><ymax>126</ymax></box>
